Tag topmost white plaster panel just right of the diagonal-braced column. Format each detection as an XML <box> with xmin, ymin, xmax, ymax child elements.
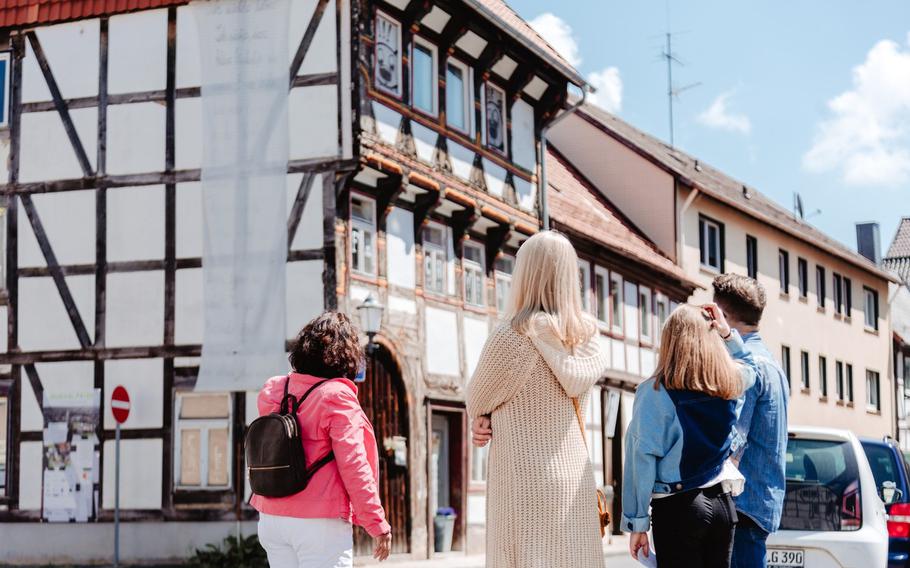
<box><xmin>109</xmin><ymin>9</ymin><xmax>167</xmax><ymax>94</ymax></box>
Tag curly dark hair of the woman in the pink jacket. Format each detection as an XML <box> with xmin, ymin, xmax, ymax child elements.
<box><xmin>288</xmin><ymin>312</ymin><xmax>363</xmax><ymax>380</ymax></box>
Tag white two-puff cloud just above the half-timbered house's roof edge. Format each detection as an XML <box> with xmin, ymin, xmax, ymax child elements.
<box><xmin>529</xmin><ymin>12</ymin><xmax>622</xmax><ymax>112</ymax></box>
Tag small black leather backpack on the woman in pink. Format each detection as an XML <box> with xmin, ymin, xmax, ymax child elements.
<box><xmin>244</xmin><ymin>375</ymin><xmax>335</xmax><ymax>497</ymax></box>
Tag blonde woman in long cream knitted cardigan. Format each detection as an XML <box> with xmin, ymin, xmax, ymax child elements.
<box><xmin>467</xmin><ymin>231</ymin><xmax>607</xmax><ymax>568</ymax></box>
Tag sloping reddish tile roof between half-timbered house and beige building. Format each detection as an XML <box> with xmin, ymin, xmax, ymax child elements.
<box><xmin>547</xmin><ymin>149</ymin><xmax>698</xmax><ymax>289</ymax></box>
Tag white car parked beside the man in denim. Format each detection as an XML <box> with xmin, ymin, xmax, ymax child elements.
<box><xmin>767</xmin><ymin>426</ymin><xmax>888</xmax><ymax>568</ymax></box>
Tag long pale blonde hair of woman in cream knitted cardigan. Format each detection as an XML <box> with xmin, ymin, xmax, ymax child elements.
<box><xmin>506</xmin><ymin>231</ymin><xmax>597</xmax><ymax>349</ymax></box>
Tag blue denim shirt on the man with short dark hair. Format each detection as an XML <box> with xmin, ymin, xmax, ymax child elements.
<box><xmin>734</xmin><ymin>333</ymin><xmax>790</xmax><ymax>533</ymax></box>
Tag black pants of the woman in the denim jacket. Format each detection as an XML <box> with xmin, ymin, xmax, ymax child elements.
<box><xmin>651</xmin><ymin>485</ymin><xmax>736</xmax><ymax>568</ymax></box>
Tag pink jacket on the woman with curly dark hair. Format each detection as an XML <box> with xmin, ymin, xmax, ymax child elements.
<box><xmin>250</xmin><ymin>373</ymin><xmax>391</xmax><ymax>536</ymax></box>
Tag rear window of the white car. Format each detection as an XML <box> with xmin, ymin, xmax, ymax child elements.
<box><xmin>781</xmin><ymin>439</ymin><xmax>862</xmax><ymax>531</ymax></box>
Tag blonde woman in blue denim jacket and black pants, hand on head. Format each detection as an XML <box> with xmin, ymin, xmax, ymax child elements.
<box><xmin>621</xmin><ymin>304</ymin><xmax>755</xmax><ymax>568</ymax></box>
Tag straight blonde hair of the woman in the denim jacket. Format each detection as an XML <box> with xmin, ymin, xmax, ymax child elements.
<box><xmin>654</xmin><ymin>304</ymin><xmax>743</xmax><ymax>400</ymax></box>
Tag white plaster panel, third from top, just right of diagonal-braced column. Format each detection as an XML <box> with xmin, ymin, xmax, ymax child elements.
<box><xmin>108</xmin><ymin>185</ymin><xmax>164</xmax><ymax>262</ymax></box>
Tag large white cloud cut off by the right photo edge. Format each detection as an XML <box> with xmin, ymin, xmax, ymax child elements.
<box><xmin>803</xmin><ymin>34</ymin><xmax>910</xmax><ymax>186</ymax></box>
